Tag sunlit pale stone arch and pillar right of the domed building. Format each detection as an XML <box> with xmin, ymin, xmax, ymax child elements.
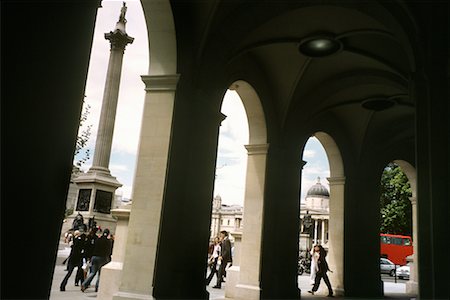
<box><xmin>314</xmin><ymin>132</ymin><xmax>345</xmax><ymax>295</ymax></box>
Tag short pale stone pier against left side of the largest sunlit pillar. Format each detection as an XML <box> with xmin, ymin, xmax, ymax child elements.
<box><xmin>97</xmin><ymin>208</ymin><xmax>130</xmax><ymax>299</ymax></box>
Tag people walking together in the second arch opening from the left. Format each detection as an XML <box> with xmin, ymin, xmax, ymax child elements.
<box><xmin>206</xmin><ymin>230</ymin><xmax>233</xmax><ymax>289</ymax></box>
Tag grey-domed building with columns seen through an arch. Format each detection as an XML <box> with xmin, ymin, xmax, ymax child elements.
<box><xmin>300</xmin><ymin>177</ymin><xmax>330</xmax><ymax>250</ymax></box>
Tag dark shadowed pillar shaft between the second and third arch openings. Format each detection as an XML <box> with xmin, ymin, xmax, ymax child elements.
<box><xmin>260</xmin><ymin>144</ymin><xmax>301</xmax><ymax>299</ymax></box>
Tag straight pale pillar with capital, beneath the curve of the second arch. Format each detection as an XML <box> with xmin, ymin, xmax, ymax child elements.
<box><xmin>236</xmin><ymin>144</ymin><xmax>268</xmax><ymax>300</ymax></box>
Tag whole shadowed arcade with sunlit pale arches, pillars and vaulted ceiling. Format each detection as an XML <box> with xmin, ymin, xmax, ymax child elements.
<box><xmin>1</xmin><ymin>0</ymin><xmax>450</xmax><ymax>300</ymax></box>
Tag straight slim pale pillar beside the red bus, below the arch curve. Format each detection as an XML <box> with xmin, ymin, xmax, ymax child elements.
<box><xmin>406</xmin><ymin>197</ymin><xmax>419</xmax><ymax>295</ymax></box>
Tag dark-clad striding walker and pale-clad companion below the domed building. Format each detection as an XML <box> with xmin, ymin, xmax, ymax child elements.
<box><xmin>308</xmin><ymin>245</ymin><xmax>333</xmax><ymax>297</ymax></box>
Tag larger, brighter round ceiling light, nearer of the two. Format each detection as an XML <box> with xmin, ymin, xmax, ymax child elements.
<box><xmin>298</xmin><ymin>35</ymin><xmax>342</xmax><ymax>57</ymax></box>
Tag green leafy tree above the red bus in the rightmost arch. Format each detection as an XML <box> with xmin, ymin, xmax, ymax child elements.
<box><xmin>380</xmin><ymin>163</ymin><xmax>412</xmax><ymax>235</ymax></box>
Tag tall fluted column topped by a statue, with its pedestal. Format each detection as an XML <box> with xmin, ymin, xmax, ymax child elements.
<box><xmin>74</xmin><ymin>3</ymin><xmax>134</xmax><ymax>230</ymax></box>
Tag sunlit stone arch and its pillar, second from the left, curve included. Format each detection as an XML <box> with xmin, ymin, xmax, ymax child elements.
<box><xmin>225</xmin><ymin>80</ymin><xmax>268</xmax><ymax>299</ymax></box>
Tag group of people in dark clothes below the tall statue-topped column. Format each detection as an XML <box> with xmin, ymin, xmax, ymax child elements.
<box><xmin>60</xmin><ymin>214</ymin><xmax>114</xmax><ymax>292</ymax></box>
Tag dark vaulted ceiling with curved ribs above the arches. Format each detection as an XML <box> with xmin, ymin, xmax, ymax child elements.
<box><xmin>172</xmin><ymin>0</ymin><xmax>416</xmax><ymax>152</ymax></box>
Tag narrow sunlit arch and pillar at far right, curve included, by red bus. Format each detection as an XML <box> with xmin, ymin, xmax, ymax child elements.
<box><xmin>394</xmin><ymin>160</ymin><xmax>419</xmax><ymax>295</ymax></box>
